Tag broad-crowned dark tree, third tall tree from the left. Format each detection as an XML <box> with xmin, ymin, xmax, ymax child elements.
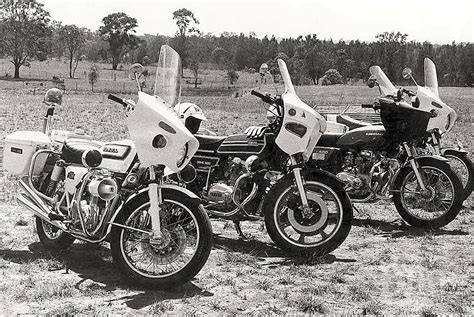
<box><xmin>99</xmin><ymin>12</ymin><xmax>139</xmax><ymax>70</ymax></box>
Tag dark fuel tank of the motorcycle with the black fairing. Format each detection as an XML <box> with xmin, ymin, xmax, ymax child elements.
<box><xmin>336</xmin><ymin>125</ymin><xmax>387</xmax><ymax>150</ymax></box>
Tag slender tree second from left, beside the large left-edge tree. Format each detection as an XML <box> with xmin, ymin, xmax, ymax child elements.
<box><xmin>59</xmin><ymin>25</ymin><xmax>87</xmax><ymax>78</ymax></box>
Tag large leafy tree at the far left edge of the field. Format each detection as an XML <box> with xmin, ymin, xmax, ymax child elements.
<box><xmin>0</xmin><ymin>1</ymin><xmax>50</xmax><ymax>78</ymax></box>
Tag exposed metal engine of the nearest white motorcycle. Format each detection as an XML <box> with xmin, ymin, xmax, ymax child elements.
<box><xmin>64</xmin><ymin>166</ymin><xmax>118</xmax><ymax>232</ymax></box>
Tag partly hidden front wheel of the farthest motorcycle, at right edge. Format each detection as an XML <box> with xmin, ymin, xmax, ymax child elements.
<box><xmin>443</xmin><ymin>150</ymin><xmax>474</xmax><ymax>201</ymax></box>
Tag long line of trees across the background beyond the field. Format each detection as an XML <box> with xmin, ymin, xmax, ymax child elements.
<box><xmin>0</xmin><ymin>0</ymin><xmax>474</xmax><ymax>87</ymax></box>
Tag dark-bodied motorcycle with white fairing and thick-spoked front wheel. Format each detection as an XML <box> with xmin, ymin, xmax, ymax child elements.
<box><xmin>180</xmin><ymin>60</ymin><xmax>352</xmax><ymax>255</ymax></box>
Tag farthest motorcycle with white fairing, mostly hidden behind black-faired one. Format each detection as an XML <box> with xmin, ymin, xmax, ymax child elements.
<box><xmin>328</xmin><ymin>58</ymin><xmax>474</xmax><ymax>201</ymax></box>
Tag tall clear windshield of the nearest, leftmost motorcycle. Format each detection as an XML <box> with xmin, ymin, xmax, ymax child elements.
<box><xmin>154</xmin><ymin>45</ymin><xmax>182</xmax><ymax>107</ymax></box>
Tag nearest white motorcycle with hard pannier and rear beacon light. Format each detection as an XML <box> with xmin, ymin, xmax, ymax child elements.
<box><xmin>4</xmin><ymin>46</ymin><xmax>212</xmax><ymax>288</ymax></box>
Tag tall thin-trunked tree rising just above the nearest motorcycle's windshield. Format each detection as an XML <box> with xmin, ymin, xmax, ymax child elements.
<box><xmin>173</xmin><ymin>8</ymin><xmax>201</xmax><ymax>67</ymax></box>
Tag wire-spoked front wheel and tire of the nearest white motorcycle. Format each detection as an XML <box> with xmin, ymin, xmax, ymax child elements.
<box><xmin>110</xmin><ymin>189</ymin><xmax>212</xmax><ymax>289</ymax></box>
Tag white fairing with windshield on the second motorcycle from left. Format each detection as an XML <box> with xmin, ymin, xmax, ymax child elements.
<box><xmin>275</xmin><ymin>59</ymin><xmax>326</xmax><ymax>160</ymax></box>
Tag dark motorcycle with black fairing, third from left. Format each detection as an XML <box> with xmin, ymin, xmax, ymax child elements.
<box><xmin>309</xmin><ymin>66</ymin><xmax>462</xmax><ymax>228</ymax></box>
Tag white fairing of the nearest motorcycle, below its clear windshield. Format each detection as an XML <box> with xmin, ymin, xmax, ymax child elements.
<box><xmin>127</xmin><ymin>92</ymin><xmax>199</xmax><ymax>172</ymax></box>
